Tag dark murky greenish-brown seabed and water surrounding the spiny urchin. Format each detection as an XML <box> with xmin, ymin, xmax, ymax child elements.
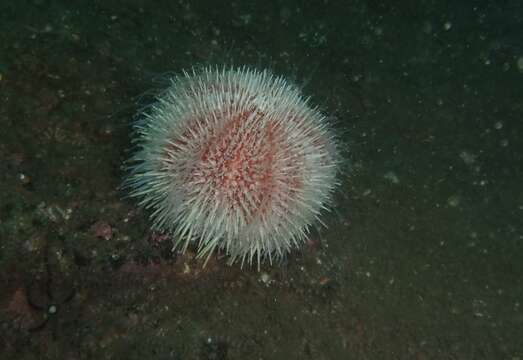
<box><xmin>0</xmin><ymin>0</ymin><xmax>523</xmax><ymax>360</ymax></box>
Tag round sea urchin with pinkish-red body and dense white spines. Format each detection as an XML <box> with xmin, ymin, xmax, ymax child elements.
<box><xmin>125</xmin><ymin>68</ymin><xmax>338</xmax><ymax>266</ymax></box>
